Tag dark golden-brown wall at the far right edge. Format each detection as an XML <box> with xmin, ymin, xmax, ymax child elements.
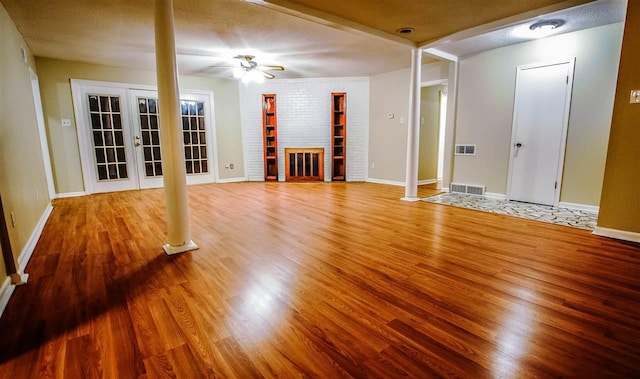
<box><xmin>598</xmin><ymin>1</ymin><xmax>640</xmax><ymax>233</ymax></box>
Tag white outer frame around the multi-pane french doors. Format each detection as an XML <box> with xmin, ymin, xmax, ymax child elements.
<box><xmin>70</xmin><ymin>79</ymin><xmax>220</xmax><ymax>195</ymax></box>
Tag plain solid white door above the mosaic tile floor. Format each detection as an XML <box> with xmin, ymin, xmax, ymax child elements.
<box><xmin>507</xmin><ymin>59</ymin><xmax>574</xmax><ymax>205</ymax></box>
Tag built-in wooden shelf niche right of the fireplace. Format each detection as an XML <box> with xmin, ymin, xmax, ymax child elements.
<box><xmin>331</xmin><ymin>92</ymin><xmax>347</xmax><ymax>181</ymax></box>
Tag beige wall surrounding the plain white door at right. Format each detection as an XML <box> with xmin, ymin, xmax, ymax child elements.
<box><xmin>454</xmin><ymin>23</ymin><xmax>623</xmax><ymax>205</ymax></box>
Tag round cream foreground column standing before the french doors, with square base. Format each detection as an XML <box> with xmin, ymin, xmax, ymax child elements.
<box><xmin>155</xmin><ymin>0</ymin><xmax>198</xmax><ymax>255</ymax></box>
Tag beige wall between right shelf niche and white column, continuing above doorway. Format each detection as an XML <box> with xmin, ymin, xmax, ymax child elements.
<box><xmin>369</xmin><ymin>60</ymin><xmax>449</xmax><ymax>183</ymax></box>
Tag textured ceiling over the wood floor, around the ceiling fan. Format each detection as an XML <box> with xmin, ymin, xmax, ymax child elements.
<box><xmin>0</xmin><ymin>0</ymin><xmax>624</xmax><ymax>78</ymax></box>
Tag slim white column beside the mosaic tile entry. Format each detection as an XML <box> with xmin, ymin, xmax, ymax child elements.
<box><xmin>402</xmin><ymin>49</ymin><xmax>422</xmax><ymax>201</ymax></box>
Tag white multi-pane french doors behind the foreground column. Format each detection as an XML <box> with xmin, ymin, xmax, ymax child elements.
<box><xmin>72</xmin><ymin>81</ymin><xmax>215</xmax><ymax>193</ymax></box>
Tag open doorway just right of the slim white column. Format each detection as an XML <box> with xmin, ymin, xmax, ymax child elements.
<box><xmin>418</xmin><ymin>80</ymin><xmax>448</xmax><ymax>189</ymax></box>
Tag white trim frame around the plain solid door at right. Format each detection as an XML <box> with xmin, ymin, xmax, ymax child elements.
<box><xmin>506</xmin><ymin>57</ymin><xmax>576</xmax><ymax>207</ymax></box>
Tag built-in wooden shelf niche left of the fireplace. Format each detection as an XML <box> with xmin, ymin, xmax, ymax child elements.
<box><xmin>262</xmin><ymin>94</ymin><xmax>278</xmax><ymax>181</ymax></box>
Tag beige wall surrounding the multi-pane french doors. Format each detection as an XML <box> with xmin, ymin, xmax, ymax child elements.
<box><xmin>36</xmin><ymin>57</ymin><xmax>245</xmax><ymax>193</ymax></box>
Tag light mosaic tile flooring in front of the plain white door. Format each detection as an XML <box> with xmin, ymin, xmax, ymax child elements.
<box><xmin>422</xmin><ymin>193</ymin><xmax>598</xmax><ymax>230</ymax></box>
